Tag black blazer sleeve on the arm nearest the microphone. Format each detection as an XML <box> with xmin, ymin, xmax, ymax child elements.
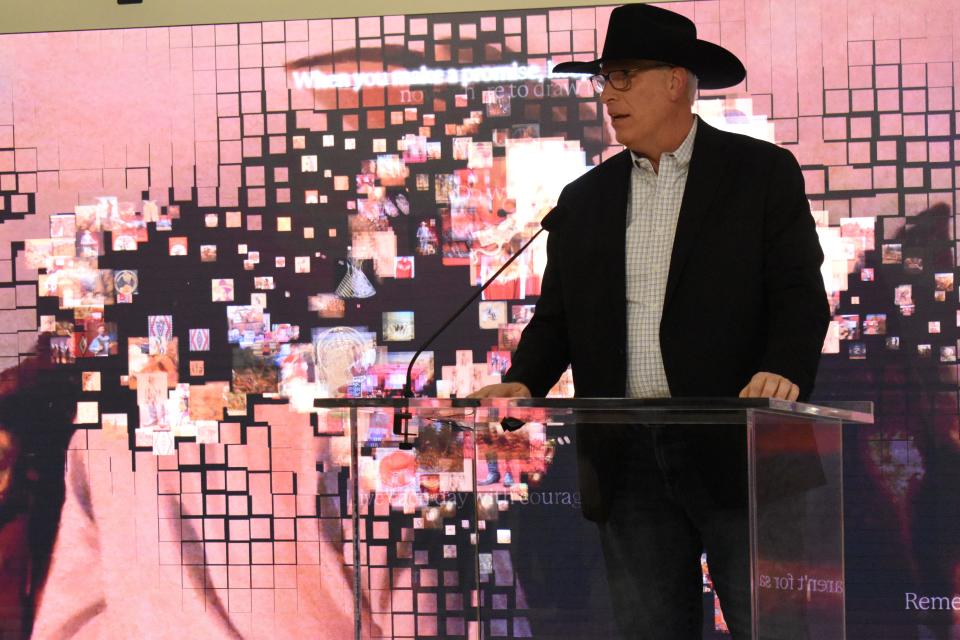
<box><xmin>503</xmin><ymin>202</ymin><xmax>570</xmax><ymax>397</ymax></box>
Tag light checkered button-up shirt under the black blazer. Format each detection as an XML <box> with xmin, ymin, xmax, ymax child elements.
<box><xmin>626</xmin><ymin>118</ymin><xmax>697</xmax><ymax>398</ymax></box>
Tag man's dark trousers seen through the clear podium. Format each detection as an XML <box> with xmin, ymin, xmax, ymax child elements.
<box><xmin>599</xmin><ymin>426</ymin><xmax>750</xmax><ymax>640</ymax></box>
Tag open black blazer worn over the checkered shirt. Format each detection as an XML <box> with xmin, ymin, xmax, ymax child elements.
<box><xmin>504</xmin><ymin>120</ymin><xmax>829</xmax><ymax>516</ymax></box>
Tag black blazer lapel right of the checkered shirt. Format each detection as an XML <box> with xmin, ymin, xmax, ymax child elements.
<box><xmin>663</xmin><ymin>116</ymin><xmax>727</xmax><ymax>310</ymax></box>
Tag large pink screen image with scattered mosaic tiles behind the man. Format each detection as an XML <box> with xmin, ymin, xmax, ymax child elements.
<box><xmin>0</xmin><ymin>0</ymin><xmax>960</xmax><ymax>638</ymax></box>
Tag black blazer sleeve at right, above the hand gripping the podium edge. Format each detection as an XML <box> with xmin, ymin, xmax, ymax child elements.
<box><xmin>760</xmin><ymin>148</ymin><xmax>830</xmax><ymax>400</ymax></box>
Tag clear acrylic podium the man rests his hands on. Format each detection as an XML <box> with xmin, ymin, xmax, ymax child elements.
<box><xmin>316</xmin><ymin>398</ymin><xmax>873</xmax><ymax>640</ymax></box>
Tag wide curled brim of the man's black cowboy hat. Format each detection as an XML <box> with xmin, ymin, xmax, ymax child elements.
<box><xmin>553</xmin><ymin>40</ymin><xmax>747</xmax><ymax>89</ymax></box>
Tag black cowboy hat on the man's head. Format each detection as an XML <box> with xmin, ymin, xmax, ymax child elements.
<box><xmin>553</xmin><ymin>4</ymin><xmax>747</xmax><ymax>89</ymax></box>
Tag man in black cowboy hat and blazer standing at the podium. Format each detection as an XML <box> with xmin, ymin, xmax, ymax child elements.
<box><xmin>474</xmin><ymin>4</ymin><xmax>829</xmax><ymax>640</ymax></box>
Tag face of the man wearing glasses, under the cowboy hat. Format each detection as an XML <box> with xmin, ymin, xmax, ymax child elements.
<box><xmin>600</xmin><ymin>60</ymin><xmax>682</xmax><ymax>154</ymax></box>
